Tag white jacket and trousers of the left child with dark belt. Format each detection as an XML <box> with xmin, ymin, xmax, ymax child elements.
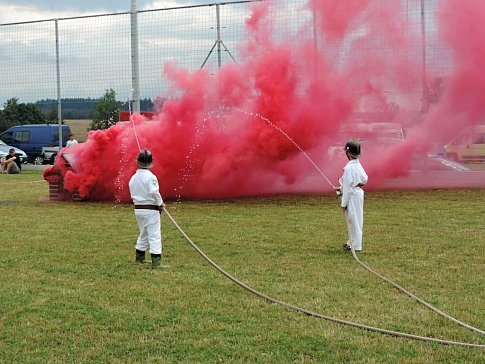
<box><xmin>128</xmin><ymin>168</ymin><xmax>163</xmax><ymax>254</ymax></box>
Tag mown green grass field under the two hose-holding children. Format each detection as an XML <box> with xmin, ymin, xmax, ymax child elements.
<box><xmin>0</xmin><ymin>171</ymin><xmax>485</xmax><ymax>363</ymax></box>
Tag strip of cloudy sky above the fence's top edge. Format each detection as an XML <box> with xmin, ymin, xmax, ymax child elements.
<box><xmin>0</xmin><ymin>0</ymin><xmax>218</xmax><ymax>24</ymax></box>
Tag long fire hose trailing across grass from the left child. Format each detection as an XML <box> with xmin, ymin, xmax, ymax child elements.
<box><xmin>163</xmin><ymin>208</ymin><xmax>485</xmax><ymax>349</ymax></box>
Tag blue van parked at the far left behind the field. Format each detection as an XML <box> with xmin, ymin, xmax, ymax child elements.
<box><xmin>0</xmin><ymin>124</ymin><xmax>71</xmax><ymax>164</ymax></box>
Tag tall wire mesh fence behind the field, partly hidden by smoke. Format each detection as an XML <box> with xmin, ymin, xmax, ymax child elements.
<box><xmin>0</xmin><ymin>0</ymin><xmax>451</xmax><ymax>136</ymax></box>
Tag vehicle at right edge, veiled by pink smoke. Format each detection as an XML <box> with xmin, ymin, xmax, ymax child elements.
<box><xmin>444</xmin><ymin>125</ymin><xmax>485</xmax><ymax>163</ymax></box>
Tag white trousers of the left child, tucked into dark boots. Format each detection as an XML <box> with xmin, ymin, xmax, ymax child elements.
<box><xmin>135</xmin><ymin>209</ymin><xmax>162</xmax><ymax>254</ymax></box>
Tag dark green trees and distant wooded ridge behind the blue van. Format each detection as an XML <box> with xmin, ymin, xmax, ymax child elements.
<box><xmin>0</xmin><ymin>89</ymin><xmax>153</xmax><ymax>132</ymax></box>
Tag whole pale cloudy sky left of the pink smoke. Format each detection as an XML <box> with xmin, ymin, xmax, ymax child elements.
<box><xmin>0</xmin><ymin>0</ymin><xmax>260</xmax><ymax>104</ymax></box>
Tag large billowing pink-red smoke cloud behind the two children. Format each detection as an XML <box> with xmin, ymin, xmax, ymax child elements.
<box><xmin>45</xmin><ymin>0</ymin><xmax>485</xmax><ymax>202</ymax></box>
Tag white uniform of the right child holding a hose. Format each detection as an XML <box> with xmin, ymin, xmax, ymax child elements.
<box><xmin>339</xmin><ymin>159</ymin><xmax>367</xmax><ymax>251</ymax></box>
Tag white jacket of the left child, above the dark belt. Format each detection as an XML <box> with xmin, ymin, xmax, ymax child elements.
<box><xmin>128</xmin><ymin>168</ymin><xmax>163</xmax><ymax>206</ymax></box>
